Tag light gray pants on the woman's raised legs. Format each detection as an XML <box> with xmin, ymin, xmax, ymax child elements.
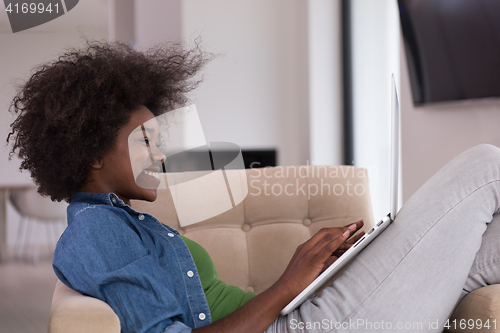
<box><xmin>266</xmin><ymin>145</ymin><xmax>500</xmax><ymax>332</ymax></box>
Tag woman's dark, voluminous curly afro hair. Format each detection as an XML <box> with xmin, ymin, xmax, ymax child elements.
<box><xmin>7</xmin><ymin>42</ymin><xmax>210</xmax><ymax>202</ymax></box>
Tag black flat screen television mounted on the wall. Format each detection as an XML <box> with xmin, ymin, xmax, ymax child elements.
<box><xmin>398</xmin><ymin>0</ymin><xmax>500</xmax><ymax>105</ymax></box>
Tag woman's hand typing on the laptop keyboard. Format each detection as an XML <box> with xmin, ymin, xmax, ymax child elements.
<box><xmin>275</xmin><ymin>221</ymin><xmax>364</xmax><ymax>300</ymax></box>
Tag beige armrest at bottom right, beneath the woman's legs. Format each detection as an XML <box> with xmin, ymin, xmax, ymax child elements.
<box><xmin>449</xmin><ymin>284</ymin><xmax>500</xmax><ymax>333</ymax></box>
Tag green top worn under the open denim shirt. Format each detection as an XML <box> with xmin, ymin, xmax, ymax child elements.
<box><xmin>180</xmin><ymin>236</ymin><xmax>255</xmax><ymax>322</ymax></box>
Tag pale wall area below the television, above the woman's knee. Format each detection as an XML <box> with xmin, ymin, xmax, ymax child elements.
<box><xmin>401</xmin><ymin>39</ymin><xmax>500</xmax><ymax>201</ymax></box>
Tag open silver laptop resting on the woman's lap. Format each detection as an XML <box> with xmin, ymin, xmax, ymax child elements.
<box><xmin>281</xmin><ymin>74</ymin><xmax>400</xmax><ymax>316</ymax></box>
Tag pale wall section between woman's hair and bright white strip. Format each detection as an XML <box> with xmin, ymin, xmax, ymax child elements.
<box><xmin>182</xmin><ymin>0</ymin><xmax>309</xmax><ymax>165</ymax></box>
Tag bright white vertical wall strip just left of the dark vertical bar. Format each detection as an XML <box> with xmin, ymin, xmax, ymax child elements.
<box><xmin>308</xmin><ymin>0</ymin><xmax>344</xmax><ymax>165</ymax></box>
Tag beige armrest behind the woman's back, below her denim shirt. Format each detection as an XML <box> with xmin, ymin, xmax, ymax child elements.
<box><xmin>49</xmin><ymin>280</ymin><xmax>120</xmax><ymax>333</ymax></box>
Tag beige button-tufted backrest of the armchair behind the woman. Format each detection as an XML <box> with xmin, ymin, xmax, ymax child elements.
<box><xmin>132</xmin><ymin>166</ymin><xmax>373</xmax><ymax>293</ymax></box>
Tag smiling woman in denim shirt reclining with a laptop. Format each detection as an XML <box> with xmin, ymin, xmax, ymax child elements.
<box><xmin>8</xmin><ymin>43</ymin><xmax>500</xmax><ymax>332</ymax></box>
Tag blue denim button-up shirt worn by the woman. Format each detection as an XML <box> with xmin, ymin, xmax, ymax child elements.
<box><xmin>53</xmin><ymin>193</ymin><xmax>211</xmax><ymax>333</ymax></box>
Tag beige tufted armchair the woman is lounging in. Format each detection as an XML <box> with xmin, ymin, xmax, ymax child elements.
<box><xmin>49</xmin><ymin>166</ymin><xmax>500</xmax><ymax>333</ymax></box>
